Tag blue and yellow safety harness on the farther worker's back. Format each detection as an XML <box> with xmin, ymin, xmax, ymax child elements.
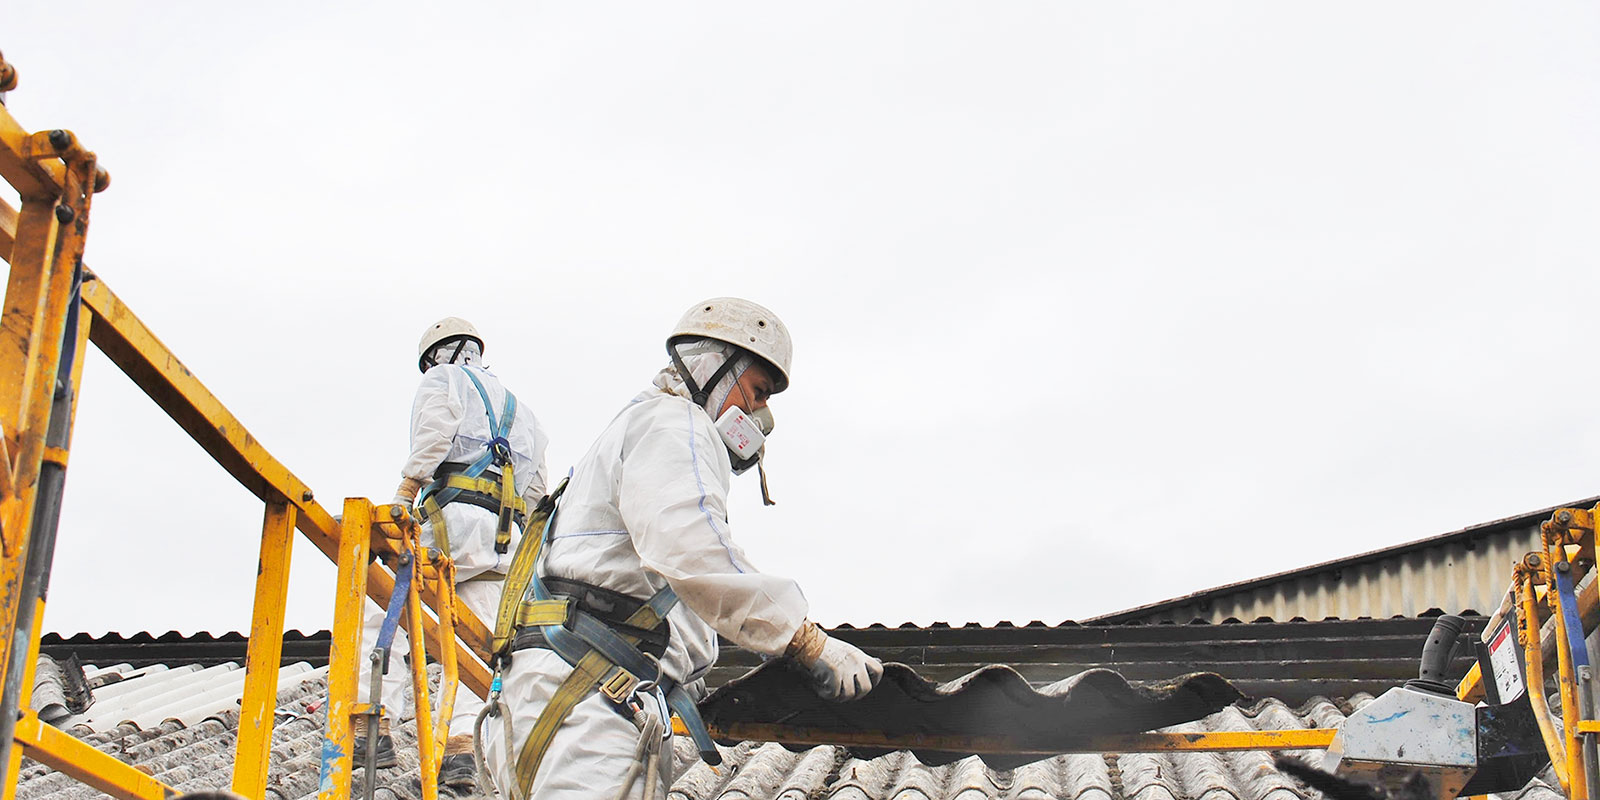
<box><xmin>418</xmin><ymin>365</ymin><xmax>528</xmax><ymax>555</ymax></box>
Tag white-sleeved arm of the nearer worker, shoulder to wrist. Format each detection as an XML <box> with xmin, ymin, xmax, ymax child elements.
<box><xmin>619</xmin><ymin>402</ymin><xmax>810</xmax><ymax>656</ymax></box>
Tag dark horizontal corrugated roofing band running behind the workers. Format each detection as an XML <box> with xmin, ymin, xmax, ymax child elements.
<box><xmin>42</xmin><ymin>618</ymin><xmax>1483</xmax><ymax>704</ymax></box>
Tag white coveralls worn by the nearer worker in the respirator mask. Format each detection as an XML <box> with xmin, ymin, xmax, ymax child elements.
<box><xmin>483</xmin><ymin>354</ymin><xmax>808</xmax><ymax>800</ymax></box>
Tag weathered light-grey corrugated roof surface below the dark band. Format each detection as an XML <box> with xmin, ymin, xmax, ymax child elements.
<box><xmin>18</xmin><ymin>669</ymin><xmax>1560</xmax><ymax>800</ymax></box>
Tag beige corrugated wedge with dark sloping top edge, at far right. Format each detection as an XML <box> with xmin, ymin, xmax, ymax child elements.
<box><xmin>1086</xmin><ymin>498</ymin><xmax>1600</xmax><ymax>624</ymax></box>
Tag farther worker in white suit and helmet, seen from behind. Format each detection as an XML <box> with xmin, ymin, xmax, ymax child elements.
<box><xmin>355</xmin><ymin>317</ymin><xmax>549</xmax><ymax>790</ymax></box>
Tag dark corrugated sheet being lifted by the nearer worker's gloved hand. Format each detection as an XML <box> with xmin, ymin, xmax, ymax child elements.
<box><xmin>699</xmin><ymin>661</ymin><xmax>1243</xmax><ymax>770</ymax></box>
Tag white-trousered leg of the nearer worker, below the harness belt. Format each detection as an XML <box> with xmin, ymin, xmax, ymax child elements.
<box><xmin>483</xmin><ymin>650</ymin><xmax>670</xmax><ymax>800</ymax></box>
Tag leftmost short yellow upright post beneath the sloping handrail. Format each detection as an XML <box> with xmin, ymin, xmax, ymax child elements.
<box><xmin>234</xmin><ymin>501</ymin><xmax>294</xmax><ymax>797</ymax></box>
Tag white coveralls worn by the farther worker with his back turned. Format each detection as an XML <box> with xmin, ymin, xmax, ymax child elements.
<box><xmin>358</xmin><ymin>360</ymin><xmax>549</xmax><ymax>734</ymax></box>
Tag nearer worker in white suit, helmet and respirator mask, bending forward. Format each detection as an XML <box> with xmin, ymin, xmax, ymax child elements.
<box><xmin>480</xmin><ymin>298</ymin><xmax>883</xmax><ymax>800</ymax></box>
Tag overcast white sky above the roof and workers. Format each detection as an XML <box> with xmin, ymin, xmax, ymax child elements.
<box><xmin>0</xmin><ymin>2</ymin><xmax>1600</xmax><ymax>634</ymax></box>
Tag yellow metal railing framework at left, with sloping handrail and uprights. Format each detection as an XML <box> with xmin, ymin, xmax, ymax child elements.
<box><xmin>0</xmin><ymin>51</ymin><xmax>490</xmax><ymax>800</ymax></box>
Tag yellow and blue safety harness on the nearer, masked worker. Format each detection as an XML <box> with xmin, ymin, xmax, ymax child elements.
<box><xmin>478</xmin><ymin>482</ymin><xmax>722</xmax><ymax>797</ymax></box>
